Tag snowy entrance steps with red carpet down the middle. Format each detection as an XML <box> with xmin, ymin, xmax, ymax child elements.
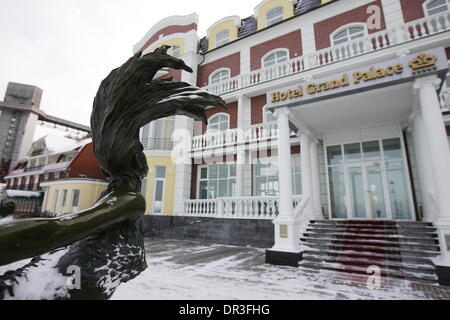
<box><xmin>299</xmin><ymin>220</ymin><xmax>439</xmax><ymax>284</ymax></box>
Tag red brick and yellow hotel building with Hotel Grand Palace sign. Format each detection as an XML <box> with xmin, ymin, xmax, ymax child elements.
<box><xmin>134</xmin><ymin>0</ymin><xmax>450</xmax><ymax>283</ymax></box>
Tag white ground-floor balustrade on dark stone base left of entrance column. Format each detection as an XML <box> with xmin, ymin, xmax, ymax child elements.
<box><xmin>184</xmin><ymin>196</ymin><xmax>302</xmax><ymax>220</ymax></box>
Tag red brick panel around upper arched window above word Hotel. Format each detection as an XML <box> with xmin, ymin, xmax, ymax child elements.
<box><xmin>250</xmin><ymin>30</ymin><xmax>303</xmax><ymax>71</ymax></box>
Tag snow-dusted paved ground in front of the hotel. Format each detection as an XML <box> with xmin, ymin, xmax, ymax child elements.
<box><xmin>113</xmin><ymin>240</ymin><xmax>450</xmax><ymax>300</ymax></box>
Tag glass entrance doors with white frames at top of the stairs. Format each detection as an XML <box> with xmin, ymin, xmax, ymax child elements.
<box><xmin>326</xmin><ymin>138</ymin><xmax>414</xmax><ymax>220</ymax></box>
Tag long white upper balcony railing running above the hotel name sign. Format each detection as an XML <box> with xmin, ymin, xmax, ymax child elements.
<box><xmin>204</xmin><ymin>11</ymin><xmax>450</xmax><ymax>94</ymax></box>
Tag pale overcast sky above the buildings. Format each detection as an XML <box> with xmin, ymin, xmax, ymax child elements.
<box><xmin>0</xmin><ymin>0</ymin><xmax>259</xmax><ymax>135</ymax></box>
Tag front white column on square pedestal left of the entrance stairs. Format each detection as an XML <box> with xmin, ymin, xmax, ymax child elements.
<box><xmin>272</xmin><ymin>108</ymin><xmax>300</xmax><ymax>253</ymax></box>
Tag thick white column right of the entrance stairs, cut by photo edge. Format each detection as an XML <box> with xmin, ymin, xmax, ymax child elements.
<box><xmin>414</xmin><ymin>76</ymin><xmax>450</xmax><ymax>266</ymax></box>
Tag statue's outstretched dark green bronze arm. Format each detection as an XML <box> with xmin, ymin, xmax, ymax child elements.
<box><xmin>0</xmin><ymin>192</ymin><xmax>145</xmax><ymax>265</ymax></box>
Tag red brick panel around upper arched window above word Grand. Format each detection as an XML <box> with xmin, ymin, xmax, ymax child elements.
<box><xmin>314</xmin><ymin>0</ymin><xmax>386</xmax><ymax>50</ymax></box>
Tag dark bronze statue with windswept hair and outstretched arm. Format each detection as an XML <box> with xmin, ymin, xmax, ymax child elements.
<box><xmin>0</xmin><ymin>46</ymin><xmax>226</xmax><ymax>299</ymax></box>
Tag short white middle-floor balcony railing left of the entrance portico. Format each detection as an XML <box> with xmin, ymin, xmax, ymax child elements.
<box><xmin>192</xmin><ymin>122</ymin><xmax>278</xmax><ymax>151</ymax></box>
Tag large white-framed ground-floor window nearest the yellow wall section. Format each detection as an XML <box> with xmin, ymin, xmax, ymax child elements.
<box><xmin>198</xmin><ymin>163</ymin><xmax>236</xmax><ymax>199</ymax></box>
